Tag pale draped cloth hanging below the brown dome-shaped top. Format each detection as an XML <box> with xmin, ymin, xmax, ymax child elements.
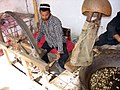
<box><xmin>70</xmin><ymin>20</ymin><xmax>100</xmax><ymax>66</ymax></box>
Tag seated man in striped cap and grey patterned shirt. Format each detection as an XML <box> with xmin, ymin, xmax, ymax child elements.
<box><xmin>36</xmin><ymin>4</ymin><xmax>69</xmax><ymax>69</ymax></box>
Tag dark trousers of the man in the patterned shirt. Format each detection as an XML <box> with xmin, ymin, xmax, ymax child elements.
<box><xmin>42</xmin><ymin>42</ymin><xmax>69</xmax><ymax>68</ymax></box>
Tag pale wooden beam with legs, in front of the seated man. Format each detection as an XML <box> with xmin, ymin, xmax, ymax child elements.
<box><xmin>0</xmin><ymin>41</ymin><xmax>48</xmax><ymax>79</ymax></box>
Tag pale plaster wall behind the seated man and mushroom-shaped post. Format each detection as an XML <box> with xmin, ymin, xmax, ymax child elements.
<box><xmin>0</xmin><ymin>0</ymin><xmax>120</xmax><ymax>35</ymax></box>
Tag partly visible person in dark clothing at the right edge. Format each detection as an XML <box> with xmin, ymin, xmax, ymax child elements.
<box><xmin>95</xmin><ymin>11</ymin><xmax>120</xmax><ymax>46</ymax></box>
